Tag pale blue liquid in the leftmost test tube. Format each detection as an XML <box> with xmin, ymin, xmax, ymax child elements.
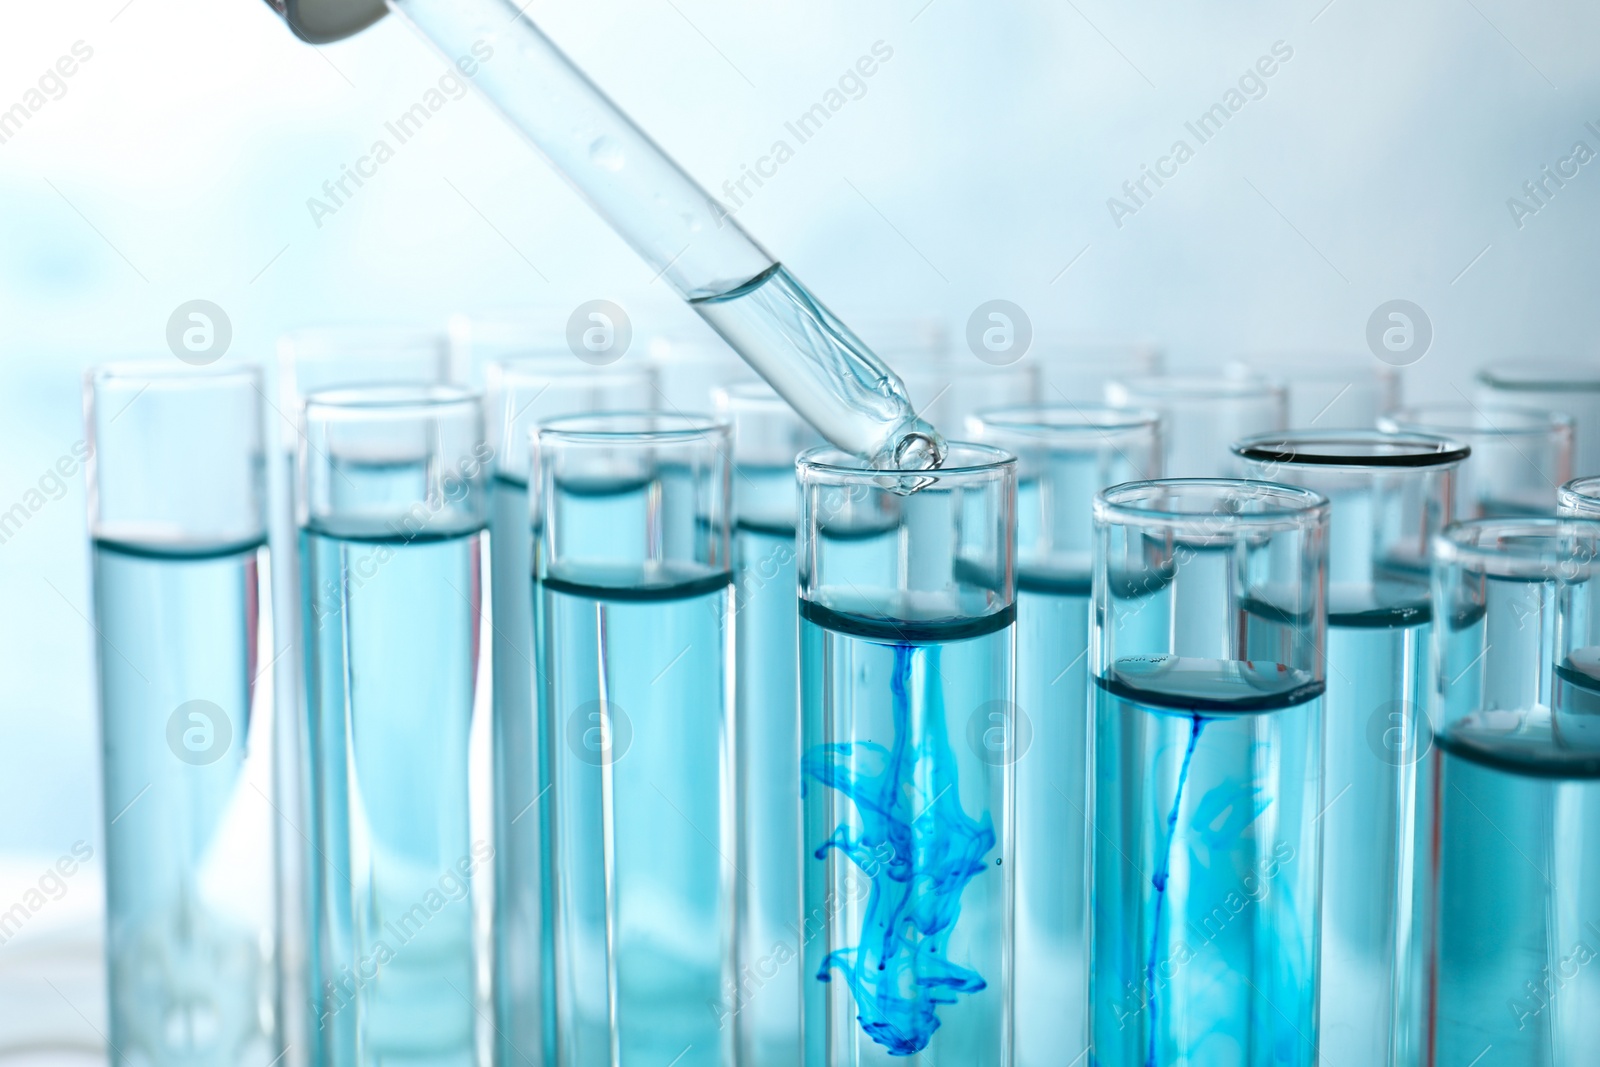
<box><xmin>94</xmin><ymin>541</ymin><xmax>282</xmax><ymax>1067</ymax></box>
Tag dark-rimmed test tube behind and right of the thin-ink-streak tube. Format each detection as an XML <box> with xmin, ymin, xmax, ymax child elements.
<box><xmin>1234</xmin><ymin>430</ymin><xmax>1467</xmax><ymax>1067</ymax></box>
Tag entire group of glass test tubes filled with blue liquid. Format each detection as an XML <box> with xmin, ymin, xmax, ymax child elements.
<box><xmin>88</xmin><ymin>329</ymin><xmax>1600</xmax><ymax>1067</ymax></box>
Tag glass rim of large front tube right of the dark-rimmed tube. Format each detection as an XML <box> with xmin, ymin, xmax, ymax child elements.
<box><xmin>1432</xmin><ymin>515</ymin><xmax>1600</xmax><ymax>582</ymax></box>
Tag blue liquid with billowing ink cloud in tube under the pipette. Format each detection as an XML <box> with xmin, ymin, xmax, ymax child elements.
<box><xmin>800</xmin><ymin>601</ymin><xmax>1014</xmax><ymax>1067</ymax></box>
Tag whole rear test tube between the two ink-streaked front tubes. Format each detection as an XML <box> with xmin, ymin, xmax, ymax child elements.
<box><xmin>970</xmin><ymin>406</ymin><xmax>1162</xmax><ymax>1067</ymax></box>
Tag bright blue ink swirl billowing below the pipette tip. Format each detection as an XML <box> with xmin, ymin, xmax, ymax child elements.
<box><xmin>802</xmin><ymin>645</ymin><xmax>995</xmax><ymax>1056</ymax></box>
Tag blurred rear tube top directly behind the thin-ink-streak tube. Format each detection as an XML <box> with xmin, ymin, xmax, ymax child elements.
<box><xmin>1106</xmin><ymin>371</ymin><xmax>1288</xmax><ymax>478</ymax></box>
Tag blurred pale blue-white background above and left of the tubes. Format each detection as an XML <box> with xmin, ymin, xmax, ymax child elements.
<box><xmin>0</xmin><ymin>0</ymin><xmax>1600</xmax><ymax>940</ymax></box>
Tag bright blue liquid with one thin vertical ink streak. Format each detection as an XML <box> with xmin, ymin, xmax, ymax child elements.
<box><xmin>1091</xmin><ymin>656</ymin><xmax>1323</xmax><ymax>1067</ymax></box>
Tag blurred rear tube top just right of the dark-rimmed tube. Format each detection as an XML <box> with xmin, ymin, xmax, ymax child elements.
<box><xmin>1378</xmin><ymin>405</ymin><xmax>1573</xmax><ymax>520</ymax></box>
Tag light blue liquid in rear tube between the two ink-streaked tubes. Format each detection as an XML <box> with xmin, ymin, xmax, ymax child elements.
<box><xmin>1013</xmin><ymin>569</ymin><xmax>1091</xmax><ymax>1067</ymax></box>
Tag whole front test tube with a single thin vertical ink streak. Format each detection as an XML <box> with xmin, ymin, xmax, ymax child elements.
<box><xmin>1090</xmin><ymin>478</ymin><xmax>1328</xmax><ymax>1067</ymax></box>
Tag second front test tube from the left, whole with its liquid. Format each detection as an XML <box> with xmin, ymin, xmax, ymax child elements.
<box><xmin>298</xmin><ymin>386</ymin><xmax>494</xmax><ymax>1067</ymax></box>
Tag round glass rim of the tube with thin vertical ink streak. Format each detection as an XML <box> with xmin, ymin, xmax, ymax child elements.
<box><xmin>1094</xmin><ymin>478</ymin><xmax>1331</xmax><ymax>541</ymax></box>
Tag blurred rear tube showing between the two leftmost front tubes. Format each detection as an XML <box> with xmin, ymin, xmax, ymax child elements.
<box><xmin>267</xmin><ymin>323</ymin><xmax>458</xmax><ymax>1067</ymax></box>
